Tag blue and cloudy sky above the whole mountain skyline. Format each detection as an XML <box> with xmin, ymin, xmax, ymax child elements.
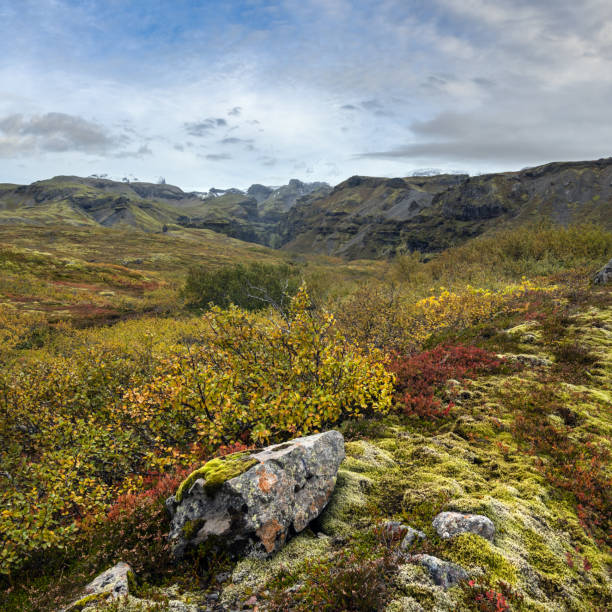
<box><xmin>0</xmin><ymin>0</ymin><xmax>612</xmax><ymax>191</ymax></box>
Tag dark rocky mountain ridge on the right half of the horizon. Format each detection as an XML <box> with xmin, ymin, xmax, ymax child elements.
<box><xmin>278</xmin><ymin>158</ymin><xmax>612</xmax><ymax>259</ymax></box>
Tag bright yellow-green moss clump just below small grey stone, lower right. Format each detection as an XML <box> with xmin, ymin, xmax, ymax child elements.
<box><xmin>445</xmin><ymin>533</ymin><xmax>517</xmax><ymax>585</ymax></box>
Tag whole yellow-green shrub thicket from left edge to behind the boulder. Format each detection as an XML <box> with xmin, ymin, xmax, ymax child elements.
<box><xmin>0</xmin><ymin>290</ymin><xmax>392</xmax><ymax>575</ymax></box>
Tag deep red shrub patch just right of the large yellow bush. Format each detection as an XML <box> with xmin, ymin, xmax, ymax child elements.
<box><xmin>390</xmin><ymin>345</ymin><xmax>507</xmax><ymax>419</ymax></box>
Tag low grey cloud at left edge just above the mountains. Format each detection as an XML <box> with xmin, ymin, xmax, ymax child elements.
<box><xmin>0</xmin><ymin>113</ymin><xmax>120</xmax><ymax>155</ymax></box>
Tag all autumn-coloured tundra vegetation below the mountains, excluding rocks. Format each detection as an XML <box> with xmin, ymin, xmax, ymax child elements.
<box><xmin>0</xmin><ymin>226</ymin><xmax>612</xmax><ymax>611</ymax></box>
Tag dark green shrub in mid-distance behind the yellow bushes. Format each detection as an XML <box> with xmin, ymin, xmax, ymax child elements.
<box><xmin>183</xmin><ymin>263</ymin><xmax>299</xmax><ymax>310</ymax></box>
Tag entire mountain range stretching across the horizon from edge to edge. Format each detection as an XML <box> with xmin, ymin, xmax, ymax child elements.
<box><xmin>0</xmin><ymin>158</ymin><xmax>612</xmax><ymax>259</ymax></box>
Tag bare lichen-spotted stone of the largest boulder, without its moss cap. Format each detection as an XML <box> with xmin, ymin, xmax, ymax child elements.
<box><xmin>166</xmin><ymin>431</ymin><xmax>344</xmax><ymax>558</ymax></box>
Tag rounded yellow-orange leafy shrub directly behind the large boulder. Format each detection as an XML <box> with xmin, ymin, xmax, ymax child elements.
<box><xmin>125</xmin><ymin>288</ymin><xmax>393</xmax><ymax>454</ymax></box>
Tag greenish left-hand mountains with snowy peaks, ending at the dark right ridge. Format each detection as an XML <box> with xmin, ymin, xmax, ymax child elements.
<box><xmin>0</xmin><ymin>176</ymin><xmax>331</xmax><ymax>244</ymax></box>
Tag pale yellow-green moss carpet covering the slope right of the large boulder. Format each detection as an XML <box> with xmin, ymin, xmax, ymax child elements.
<box><xmin>224</xmin><ymin>298</ymin><xmax>612</xmax><ymax>612</ymax></box>
